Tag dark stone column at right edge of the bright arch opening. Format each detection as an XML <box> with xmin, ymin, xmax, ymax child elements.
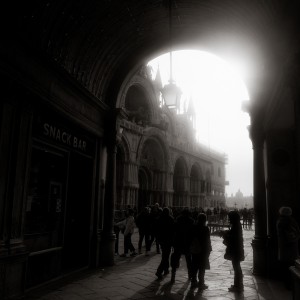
<box><xmin>250</xmin><ymin>126</ymin><xmax>268</xmax><ymax>275</ymax></box>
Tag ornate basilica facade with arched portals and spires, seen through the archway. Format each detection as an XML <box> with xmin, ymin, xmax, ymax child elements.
<box><xmin>116</xmin><ymin>66</ymin><xmax>226</xmax><ymax>210</ymax></box>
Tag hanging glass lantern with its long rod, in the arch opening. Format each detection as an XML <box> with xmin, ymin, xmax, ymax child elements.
<box><xmin>161</xmin><ymin>0</ymin><xmax>182</xmax><ymax>108</ymax></box>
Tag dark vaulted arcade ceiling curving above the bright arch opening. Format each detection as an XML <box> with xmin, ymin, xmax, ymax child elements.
<box><xmin>3</xmin><ymin>0</ymin><xmax>300</xmax><ymax>112</ymax></box>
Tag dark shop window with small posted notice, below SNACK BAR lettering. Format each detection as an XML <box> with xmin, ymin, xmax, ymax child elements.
<box><xmin>24</xmin><ymin>148</ymin><xmax>67</xmax><ymax>252</ymax></box>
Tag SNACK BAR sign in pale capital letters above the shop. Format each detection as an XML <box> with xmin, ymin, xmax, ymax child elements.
<box><xmin>43</xmin><ymin>123</ymin><xmax>87</xmax><ymax>152</ymax></box>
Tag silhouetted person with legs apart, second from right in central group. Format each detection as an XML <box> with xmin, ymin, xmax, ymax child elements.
<box><xmin>171</xmin><ymin>208</ymin><xmax>194</xmax><ymax>282</ymax></box>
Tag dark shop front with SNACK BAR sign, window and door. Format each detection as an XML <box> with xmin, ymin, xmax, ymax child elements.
<box><xmin>24</xmin><ymin>114</ymin><xmax>95</xmax><ymax>288</ymax></box>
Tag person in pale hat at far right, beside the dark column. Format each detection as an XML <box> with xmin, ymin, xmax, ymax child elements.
<box><xmin>276</xmin><ymin>207</ymin><xmax>300</xmax><ymax>289</ymax></box>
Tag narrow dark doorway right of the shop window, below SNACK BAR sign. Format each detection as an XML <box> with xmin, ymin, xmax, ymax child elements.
<box><xmin>63</xmin><ymin>153</ymin><xmax>93</xmax><ymax>271</ymax></box>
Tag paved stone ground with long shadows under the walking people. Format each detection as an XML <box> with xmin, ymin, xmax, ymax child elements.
<box><xmin>26</xmin><ymin>230</ymin><xmax>292</xmax><ymax>300</ymax></box>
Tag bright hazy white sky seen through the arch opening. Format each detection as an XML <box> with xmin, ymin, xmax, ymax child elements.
<box><xmin>150</xmin><ymin>51</ymin><xmax>253</xmax><ymax>196</ymax></box>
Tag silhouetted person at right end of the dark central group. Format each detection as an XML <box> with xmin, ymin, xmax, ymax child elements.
<box><xmin>191</xmin><ymin>213</ymin><xmax>212</xmax><ymax>290</ymax></box>
